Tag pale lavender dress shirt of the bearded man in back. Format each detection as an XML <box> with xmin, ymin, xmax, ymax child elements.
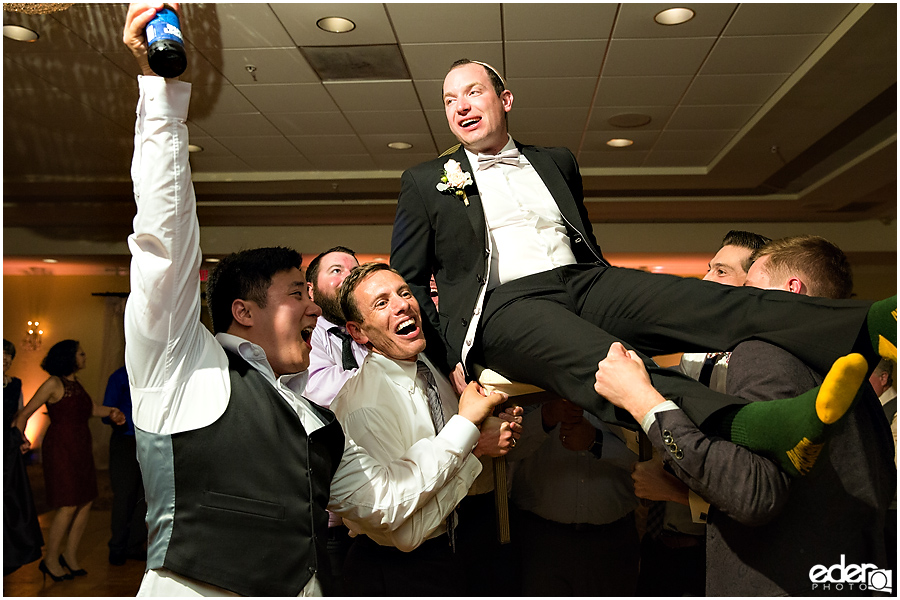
<box><xmin>304</xmin><ymin>317</ymin><xmax>369</xmax><ymax>408</ymax></box>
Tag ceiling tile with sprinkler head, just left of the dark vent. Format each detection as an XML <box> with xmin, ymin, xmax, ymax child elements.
<box><xmin>205</xmin><ymin>48</ymin><xmax>319</xmax><ymax>85</ymax></box>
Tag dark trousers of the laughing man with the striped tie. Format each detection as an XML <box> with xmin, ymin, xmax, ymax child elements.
<box><xmin>344</xmin><ymin>534</ymin><xmax>460</xmax><ymax>596</ymax></box>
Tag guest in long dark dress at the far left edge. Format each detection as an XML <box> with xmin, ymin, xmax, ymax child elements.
<box><xmin>3</xmin><ymin>339</ymin><xmax>44</xmax><ymax>576</ymax></box>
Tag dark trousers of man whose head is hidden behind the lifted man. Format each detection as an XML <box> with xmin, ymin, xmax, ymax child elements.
<box><xmin>512</xmin><ymin>510</ymin><xmax>640</xmax><ymax>596</ymax></box>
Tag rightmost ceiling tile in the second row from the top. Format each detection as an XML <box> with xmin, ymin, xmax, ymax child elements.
<box><xmin>700</xmin><ymin>34</ymin><xmax>825</xmax><ymax>75</ymax></box>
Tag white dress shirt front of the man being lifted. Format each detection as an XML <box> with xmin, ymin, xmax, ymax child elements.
<box><xmin>466</xmin><ymin>137</ymin><xmax>578</xmax><ymax>289</ymax></box>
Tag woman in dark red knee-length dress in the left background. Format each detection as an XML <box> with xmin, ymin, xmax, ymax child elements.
<box><xmin>16</xmin><ymin>340</ymin><xmax>125</xmax><ymax>581</ymax></box>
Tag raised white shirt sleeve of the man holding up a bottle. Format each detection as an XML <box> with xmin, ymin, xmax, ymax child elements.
<box><xmin>125</xmin><ymin>76</ymin><xmax>230</xmax><ymax>433</ymax></box>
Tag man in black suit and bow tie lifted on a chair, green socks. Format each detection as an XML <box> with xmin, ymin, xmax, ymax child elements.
<box><xmin>391</xmin><ymin>61</ymin><xmax>897</xmax><ymax>473</ymax></box>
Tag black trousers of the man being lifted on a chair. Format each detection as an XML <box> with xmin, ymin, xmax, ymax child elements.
<box><xmin>486</xmin><ymin>265</ymin><xmax>878</xmax><ymax>428</ymax></box>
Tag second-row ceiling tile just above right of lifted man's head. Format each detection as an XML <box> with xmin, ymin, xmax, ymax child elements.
<box><xmin>505</xmin><ymin>40</ymin><xmax>606</xmax><ymax>77</ymax></box>
